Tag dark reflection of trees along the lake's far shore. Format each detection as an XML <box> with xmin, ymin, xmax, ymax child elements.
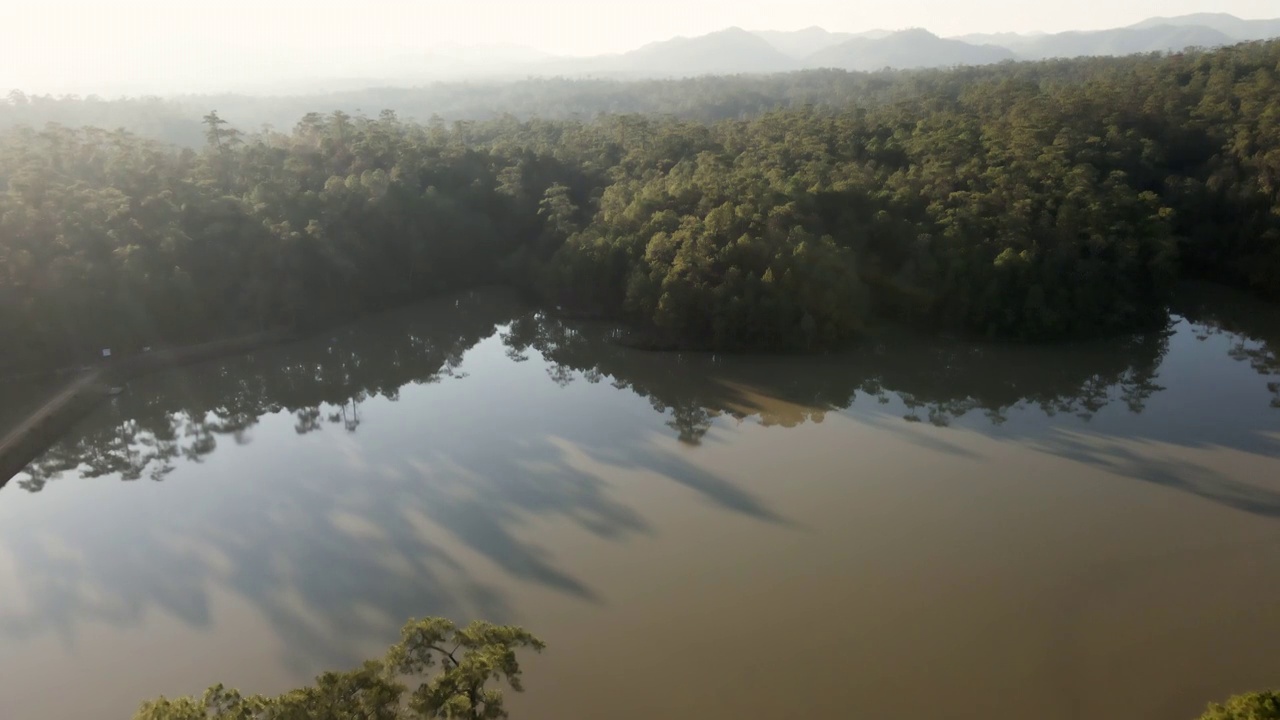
<box><xmin>17</xmin><ymin>281</ymin><xmax>1280</xmax><ymax>492</ymax></box>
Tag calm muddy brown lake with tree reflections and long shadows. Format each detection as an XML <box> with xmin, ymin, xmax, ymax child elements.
<box><xmin>0</xmin><ymin>288</ymin><xmax>1280</xmax><ymax>720</ymax></box>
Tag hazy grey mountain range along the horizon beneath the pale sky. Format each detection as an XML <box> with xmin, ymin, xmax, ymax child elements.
<box><xmin>12</xmin><ymin>13</ymin><xmax>1280</xmax><ymax>95</ymax></box>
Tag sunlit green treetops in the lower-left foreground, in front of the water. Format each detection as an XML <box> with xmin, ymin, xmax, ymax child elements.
<box><xmin>134</xmin><ymin>618</ymin><xmax>545</xmax><ymax>720</ymax></box>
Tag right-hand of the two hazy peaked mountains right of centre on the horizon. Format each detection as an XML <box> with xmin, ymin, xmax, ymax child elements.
<box><xmin>804</xmin><ymin>29</ymin><xmax>1014</xmax><ymax>70</ymax></box>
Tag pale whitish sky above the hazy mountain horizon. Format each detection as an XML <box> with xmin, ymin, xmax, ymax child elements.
<box><xmin>0</xmin><ymin>0</ymin><xmax>1280</xmax><ymax>94</ymax></box>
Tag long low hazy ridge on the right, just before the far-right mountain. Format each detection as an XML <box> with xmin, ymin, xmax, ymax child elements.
<box><xmin>1018</xmin><ymin>26</ymin><xmax>1236</xmax><ymax>60</ymax></box>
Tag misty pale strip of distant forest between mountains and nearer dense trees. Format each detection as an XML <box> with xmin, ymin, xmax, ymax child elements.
<box><xmin>0</xmin><ymin>67</ymin><xmax>1003</xmax><ymax>147</ymax></box>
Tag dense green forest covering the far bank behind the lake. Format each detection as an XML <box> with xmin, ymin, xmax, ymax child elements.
<box><xmin>0</xmin><ymin>44</ymin><xmax>1280</xmax><ymax>368</ymax></box>
